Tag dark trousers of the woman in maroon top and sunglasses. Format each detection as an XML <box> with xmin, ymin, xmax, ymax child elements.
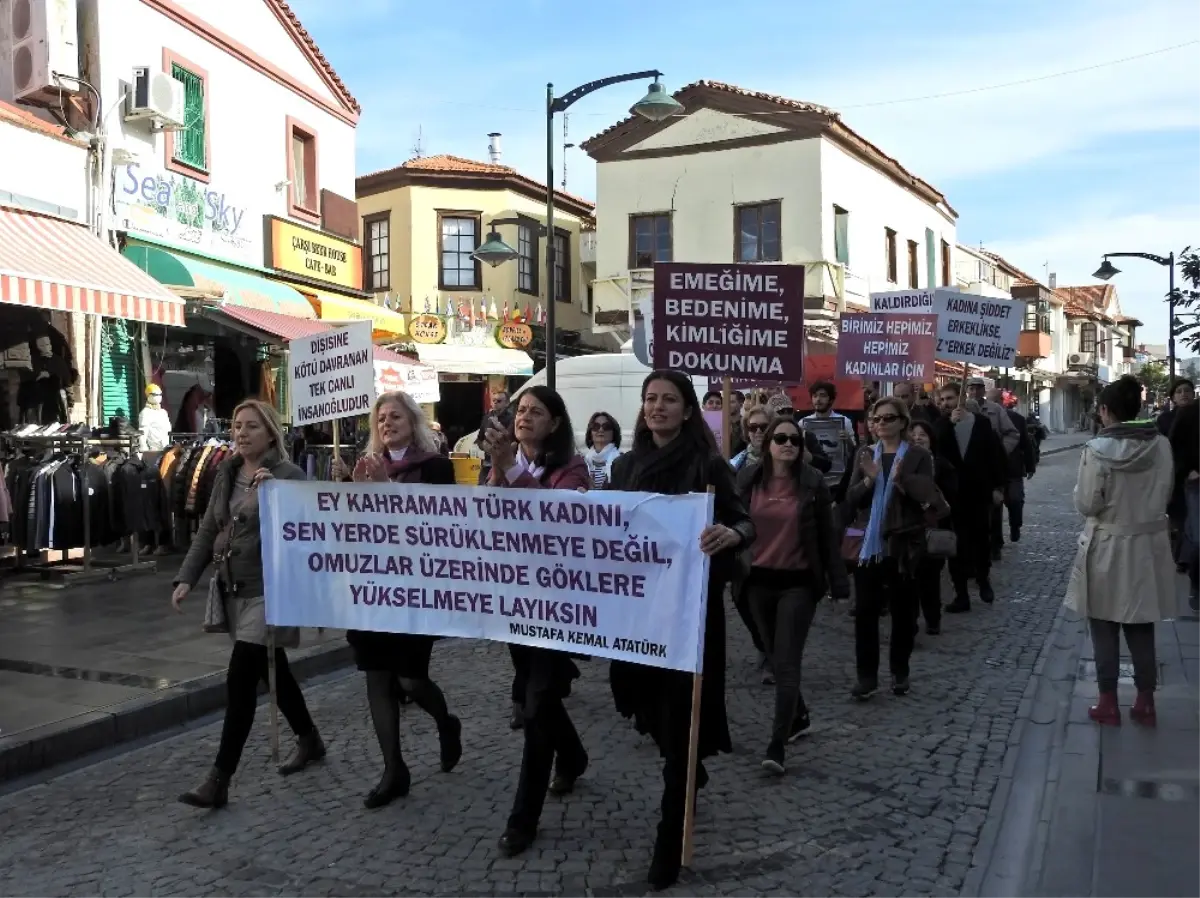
<box><xmin>748</xmin><ymin>571</ymin><xmax>817</xmax><ymax>744</ymax></box>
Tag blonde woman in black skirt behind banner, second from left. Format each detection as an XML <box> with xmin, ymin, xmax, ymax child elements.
<box><xmin>332</xmin><ymin>393</ymin><xmax>462</xmax><ymax>808</ymax></box>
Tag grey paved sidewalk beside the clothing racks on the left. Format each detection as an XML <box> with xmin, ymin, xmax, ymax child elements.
<box><xmin>0</xmin><ymin>556</ymin><xmax>349</xmax><ymax>783</ymax></box>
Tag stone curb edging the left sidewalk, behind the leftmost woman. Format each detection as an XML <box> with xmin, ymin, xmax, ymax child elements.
<box><xmin>0</xmin><ymin>641</ymin><xmax>354</xmax><ymax>788</ymax></box>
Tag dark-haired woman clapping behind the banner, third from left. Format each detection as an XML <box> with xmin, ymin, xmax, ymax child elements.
<box><xmin>484</xmin><ymin>387</ymin><xmax>592</xmax><ymax>857</ymax></box>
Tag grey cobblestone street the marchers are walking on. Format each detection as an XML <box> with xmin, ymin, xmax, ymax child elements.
<box><xmin>0</xmin><ymin>450</ymin><xmax>1079</xmax><ymax>898</ymax></box>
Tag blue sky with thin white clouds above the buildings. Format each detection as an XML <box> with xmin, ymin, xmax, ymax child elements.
<box><xmin>290</xmin><ymin>0</ymin><xmax>1200</xmax><ymax>342</ymax></box>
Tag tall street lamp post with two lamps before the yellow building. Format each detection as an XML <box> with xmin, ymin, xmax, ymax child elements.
<box><xmin>474</xmin><ymin>70</ymin><xmax>683</xmax><ymax>389</ymax></box>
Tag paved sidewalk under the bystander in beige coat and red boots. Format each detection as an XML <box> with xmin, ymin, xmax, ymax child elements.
<box><xmin>965</xmin><ymin>569</ymin><xmax>1200</xmax><ymax>898</ymax></box>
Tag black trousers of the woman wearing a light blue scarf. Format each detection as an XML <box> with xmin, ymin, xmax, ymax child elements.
<box><xmin>854</xmin><ymin>558</ymin><xmax>917</xmax><ymax>682</ymax></box>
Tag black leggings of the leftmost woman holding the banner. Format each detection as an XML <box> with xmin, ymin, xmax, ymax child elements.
<box><xmin>214</xmin><ymin>642</ymin><xmax>317</xmax><ymax>777</ymax></box>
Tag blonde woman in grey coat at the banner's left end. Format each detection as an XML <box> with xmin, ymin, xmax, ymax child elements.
<box><xmin>170</xmin><ymin>400</ymin><xmax>325</xmax><ymax>808</ymax></box>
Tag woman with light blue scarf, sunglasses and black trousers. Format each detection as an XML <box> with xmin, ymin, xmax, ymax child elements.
<box><xmin>846</xmin><ymin>396</ymin><xmax>947</xmax><ymax>701</ymax></box>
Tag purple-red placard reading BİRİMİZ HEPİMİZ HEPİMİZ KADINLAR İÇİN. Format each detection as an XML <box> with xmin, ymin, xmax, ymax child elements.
<box><xmin>838</xmin><ymin>312</ymin><xmax>937</xmax><ymax>383</ymax></box>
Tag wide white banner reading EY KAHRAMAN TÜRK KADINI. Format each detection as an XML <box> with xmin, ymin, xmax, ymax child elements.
<box><xmin>259</xmin><ymin>480</ymin><xmax>713</xmax><ymax>674</ymax></box>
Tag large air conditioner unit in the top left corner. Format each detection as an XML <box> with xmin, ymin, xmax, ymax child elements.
<box><xmin>9</xmin><ymin>0</ymin><xmax>79</xmax><ymax>106</ymax></box>
